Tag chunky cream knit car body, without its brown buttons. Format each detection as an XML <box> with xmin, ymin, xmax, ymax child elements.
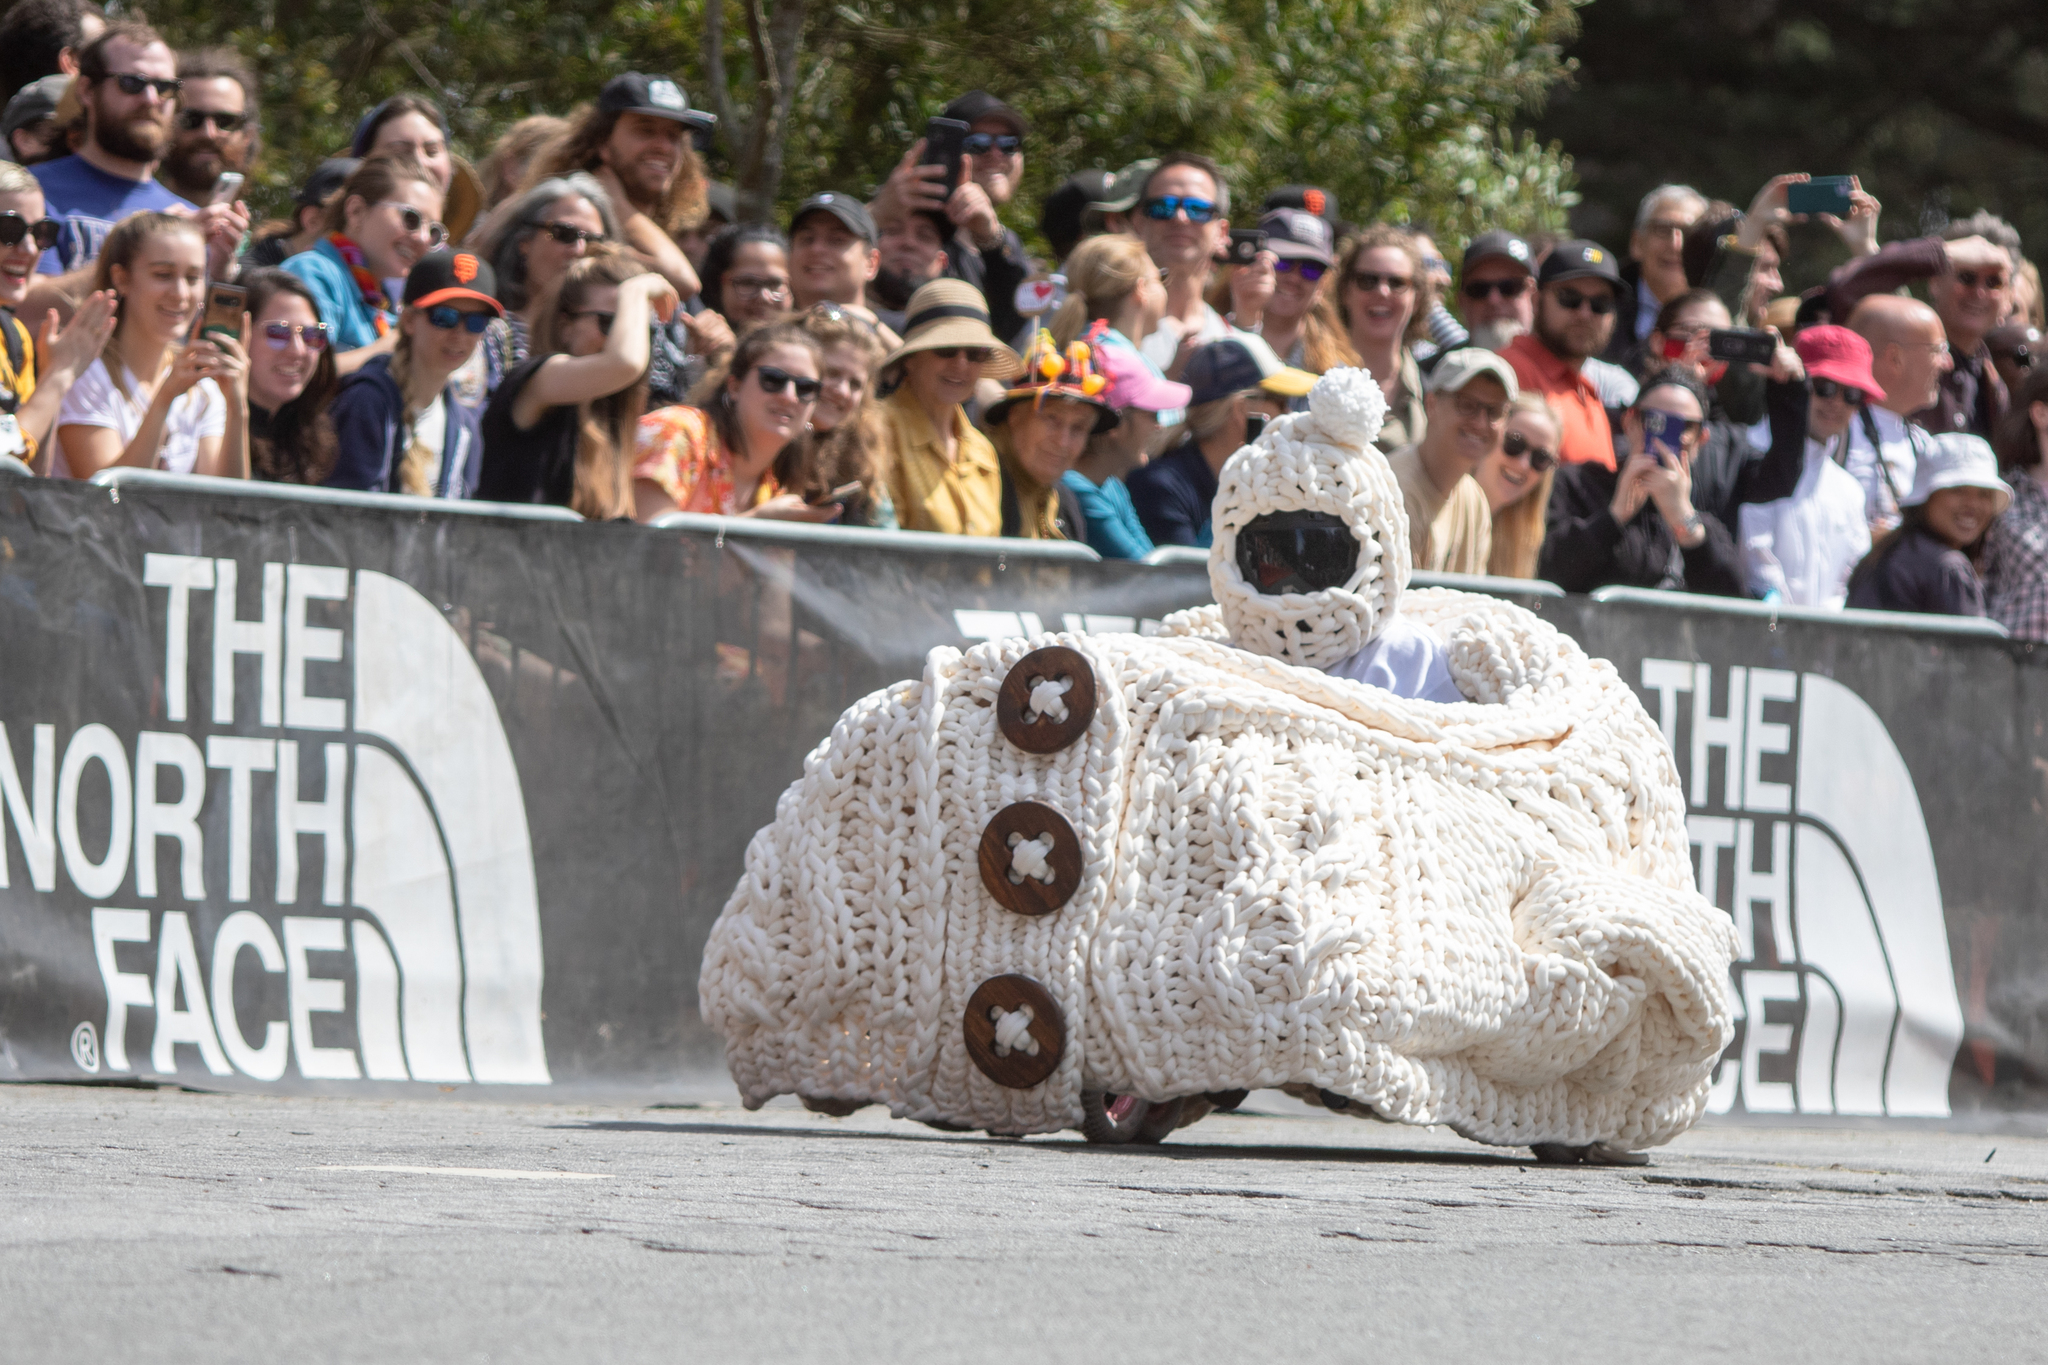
<box><xmin>698</xmin><ymin>589</ymin><xmax>1735</xmax><ymax>1148</ymax></box>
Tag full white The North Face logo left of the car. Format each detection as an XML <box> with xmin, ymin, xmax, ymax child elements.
<box><xmin>0</xmin><ymin>555</ymin><xmax>549</xmax><ymax>1085</ymax></box>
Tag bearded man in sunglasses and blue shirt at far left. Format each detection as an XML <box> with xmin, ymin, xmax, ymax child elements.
<box><xmin>29</xmin><ymin>23</ymin><xmax>193</xmax><ymax>274</ymax></box>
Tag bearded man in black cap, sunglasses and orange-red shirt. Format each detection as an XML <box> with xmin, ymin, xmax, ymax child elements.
<box><xmin>1501</xmin><ymin>241</ymin><xmax>1613</xmax><ymax>469</ymax></box>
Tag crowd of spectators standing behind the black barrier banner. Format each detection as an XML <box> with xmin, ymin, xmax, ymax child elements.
<box><xmin>0</xmin><ymin>0</ymin><xmax>2048</xmax><ymax>639</ymax></box>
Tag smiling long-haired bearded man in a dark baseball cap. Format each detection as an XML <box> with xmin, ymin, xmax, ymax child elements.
<box><xmin>526</xmin><ymin>72</ymin><xmax>708</xmax><ymax>298</ymax></box>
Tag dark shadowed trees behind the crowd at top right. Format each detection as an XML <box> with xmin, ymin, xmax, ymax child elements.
<box><xmin>1536</xmin><ymin>0</ymin><xmax>2048</xmax><ymax>284</ymax></box>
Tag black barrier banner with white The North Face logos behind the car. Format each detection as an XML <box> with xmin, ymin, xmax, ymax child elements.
<box><xmin>0</xmin><ymin>479</ymin><xmax>2048</xmax><ymax>1117</ymax></box>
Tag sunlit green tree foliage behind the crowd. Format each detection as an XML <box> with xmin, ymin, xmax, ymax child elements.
<box><xmin>140</xmin><ymin>0</ymin><xmax>1583</xmax><ymax>246</ymax></box>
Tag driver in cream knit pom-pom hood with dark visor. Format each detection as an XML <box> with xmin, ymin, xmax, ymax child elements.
<box><xmin>1208</xmin><ymin>368</ymin><xmax>1466</xmax><ymax>702</ymax></box>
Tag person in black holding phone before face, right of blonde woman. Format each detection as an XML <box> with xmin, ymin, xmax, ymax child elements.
<box><xmin>1538</xmin><ymin>368</ymin><xmax>1743</xmax><ymax>598</ymax></box>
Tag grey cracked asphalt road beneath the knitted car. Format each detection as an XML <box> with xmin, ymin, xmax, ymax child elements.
<box><xmin>0</xmin><ymin>1087</ymin><xmax>2048</xmax><ymax>1365</ymax></box>
